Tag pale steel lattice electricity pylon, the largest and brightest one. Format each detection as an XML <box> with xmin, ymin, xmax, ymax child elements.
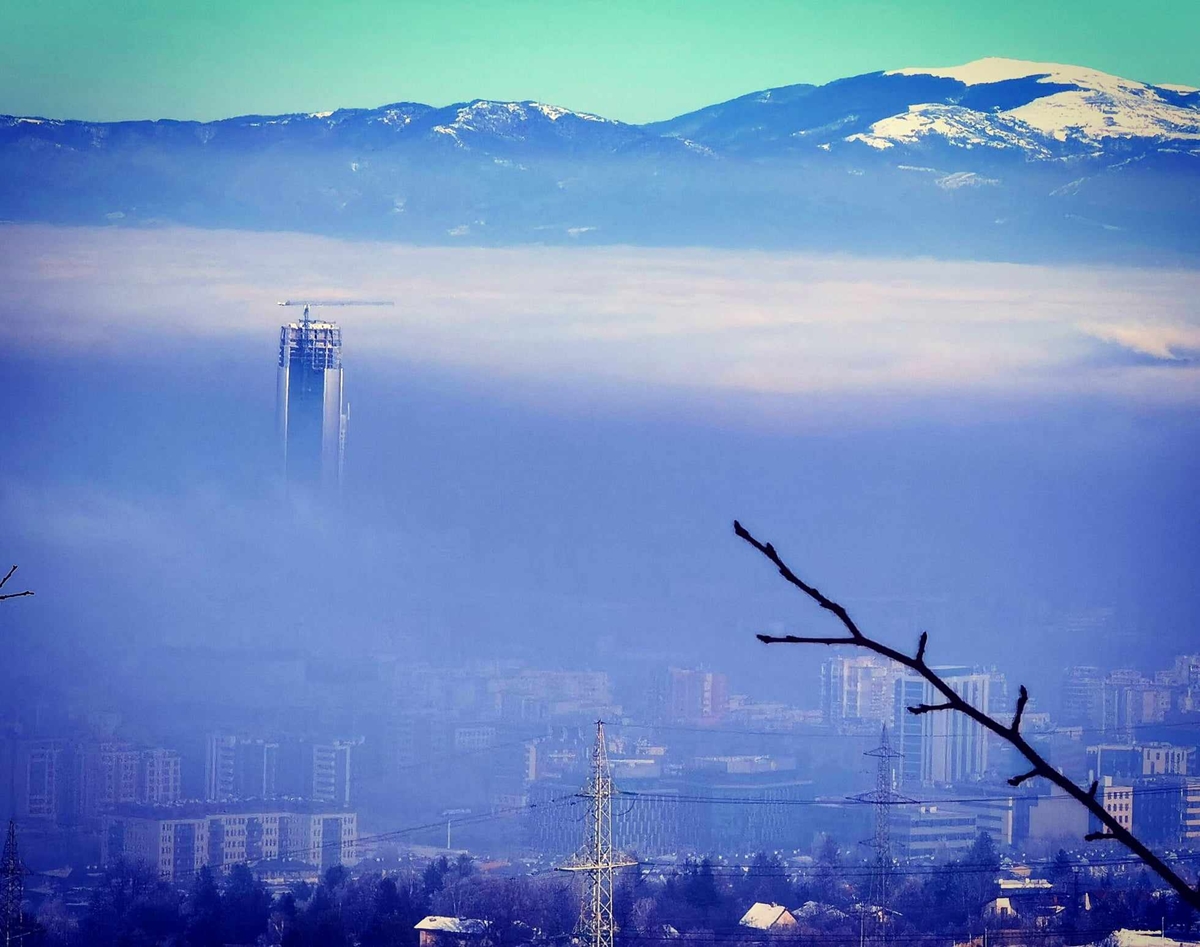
<box><xmin>558</xmin><ymin>720</ymin><xmax>637</xmax><ymax>947</ymax></box>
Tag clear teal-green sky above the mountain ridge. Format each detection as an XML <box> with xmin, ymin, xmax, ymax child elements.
<box><xmin>0</xmin><ymin>0</ymin><xmax>1200</xmax><ymax>121</ymax></box>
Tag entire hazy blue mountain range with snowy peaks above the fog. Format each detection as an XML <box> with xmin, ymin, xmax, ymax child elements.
<box><xmin>0</xmin><ymin>59</ymin><xmax>1200</xmax><ymax>265</ymax></box>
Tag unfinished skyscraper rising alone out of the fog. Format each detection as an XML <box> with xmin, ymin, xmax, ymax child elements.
<box><xmin>276</xmin><ymin>306</ymin><xmax>350</xmax><ymax>490</ymax></box>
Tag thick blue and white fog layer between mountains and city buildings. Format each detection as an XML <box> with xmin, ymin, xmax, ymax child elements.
<box><xmin>0</xmin><ymin>226</ymin><xmax>1200</xmax><ymax>706</ymax></box>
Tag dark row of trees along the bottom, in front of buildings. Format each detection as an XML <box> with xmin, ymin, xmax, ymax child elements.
<box><xmin>28</xmin><ymin>835</ymin><xmax>1196</xmax><ymax>947</ymax></box>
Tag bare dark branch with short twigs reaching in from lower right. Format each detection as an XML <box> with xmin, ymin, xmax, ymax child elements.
<box><xmin>733</xmin><ymin>520</ymin><xmax>1200</xmax><ymax>910</ymax></box>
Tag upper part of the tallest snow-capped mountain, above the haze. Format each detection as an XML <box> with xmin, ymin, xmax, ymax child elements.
<box><xmin>648</xmin><ymin>59</ymin><xmax>1200</xmax><ymax>158</ymax></box>
